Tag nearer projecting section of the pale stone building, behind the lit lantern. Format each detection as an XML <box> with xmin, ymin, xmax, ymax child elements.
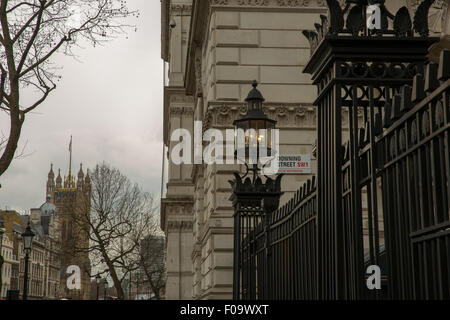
<box><xmin>185</xmin><ymin>1</ymin><xmax>326</xmax><ymax>299</ymax></box>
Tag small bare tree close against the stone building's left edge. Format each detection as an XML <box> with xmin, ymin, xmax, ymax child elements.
<box><xmin>139</xmin><ymin>232</ymin><xmax>166</xmax><ymax>300</ymax></box>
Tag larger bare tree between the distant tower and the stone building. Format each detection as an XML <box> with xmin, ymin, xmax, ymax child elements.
<box><xmin>74</xmin><ymin>163</ymin><xmax>156</xmax><ymax>300</ymax></box>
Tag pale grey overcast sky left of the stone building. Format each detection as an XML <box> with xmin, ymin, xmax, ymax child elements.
<box><xmin>0</xmin><ymin>0</ymin><xmax>163</xmax><ymax>214</ymax></box>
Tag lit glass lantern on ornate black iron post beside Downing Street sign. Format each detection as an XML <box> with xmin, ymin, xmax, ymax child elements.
<box><xmin>230</xmin><ymin>81</ymin><xmax>283</xmax><ymax>300</ymax></box>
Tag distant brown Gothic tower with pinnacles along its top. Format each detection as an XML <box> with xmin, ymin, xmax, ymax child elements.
<box><xmin>47</xmin><ymin>165</ymin><xmax>91</xmax><ymax>300</ymax></box>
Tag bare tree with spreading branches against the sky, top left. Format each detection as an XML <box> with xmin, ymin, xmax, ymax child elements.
<box><xmin>0</xmin><ymin>0</ymin><xmax>137</xmax><ymax>176</ymax></box>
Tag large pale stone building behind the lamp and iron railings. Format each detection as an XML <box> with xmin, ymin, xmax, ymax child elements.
<box><xmin>161</xmin><ymin>0</ymin><xmax>447</xmax><ymax>299</ymax></box>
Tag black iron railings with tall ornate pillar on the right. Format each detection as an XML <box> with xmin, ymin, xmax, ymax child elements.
<box><xmin>234</xmin><ymin>0</ymin><xmax>450</xmax><ymax>299</ymax></box>
